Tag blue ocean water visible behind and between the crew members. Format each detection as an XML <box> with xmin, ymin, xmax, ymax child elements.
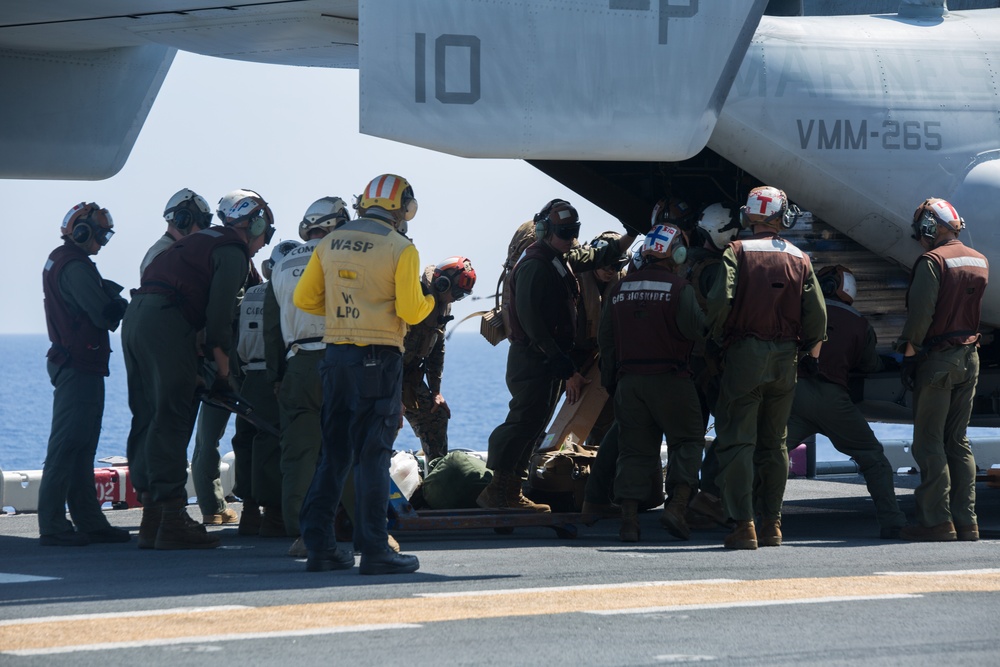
<box><xmin>0</xmin><ymin>332</ymin><xmax>960</xmax><ymax>471</ymax></box>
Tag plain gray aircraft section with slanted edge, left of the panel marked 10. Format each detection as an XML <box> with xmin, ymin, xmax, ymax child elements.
<box><xmin>0</xmin><ymin>0</ymin><xmax>358</xmax><ymax>180</ymax></box>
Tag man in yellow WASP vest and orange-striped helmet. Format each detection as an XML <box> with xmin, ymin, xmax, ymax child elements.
<box><xmin>293</xmin><ymin>174</ymin><xmax>434</xmax><ymax>574</ymax></box>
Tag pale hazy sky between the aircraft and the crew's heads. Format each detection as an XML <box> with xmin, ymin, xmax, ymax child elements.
<box><xmin>0</xmin><ymin>48</ymin><xmax>621</xmax><ymax>333</ymax></box>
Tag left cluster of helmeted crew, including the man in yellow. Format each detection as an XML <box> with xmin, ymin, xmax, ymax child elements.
<box><xmin>39</xmin><ymin>174</ymin><xmax>476</xmax><ymax>574</ymax></box>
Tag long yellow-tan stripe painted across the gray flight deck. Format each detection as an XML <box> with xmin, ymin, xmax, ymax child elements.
<box><xmin>0</xmin><ymin>572</ymin><xmax>1000</xmax><ymax>651</ymax></box>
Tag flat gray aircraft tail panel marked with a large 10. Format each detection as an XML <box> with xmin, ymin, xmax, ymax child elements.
<box><xmin>359</xmin><ymin>0</ymin><xmax>767</xmax><ymax>161</ymax></box>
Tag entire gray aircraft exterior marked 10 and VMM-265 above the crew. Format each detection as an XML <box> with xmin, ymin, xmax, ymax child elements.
<box><xmin>0</xmin><ymin>0</ymin><xmax>1000</xmax><ymax>334</ymax></box>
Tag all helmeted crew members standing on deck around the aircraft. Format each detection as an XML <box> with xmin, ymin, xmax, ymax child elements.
<box><xmin>38</xmin><ymin>174</ymin><xmax>988</xmax><ymax>574</ymax></box>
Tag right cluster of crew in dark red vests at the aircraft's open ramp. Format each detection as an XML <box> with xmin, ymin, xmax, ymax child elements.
<box><xmin>488</xmin><ymin>186</ymin><xmax>988</xmax><ymax>549</ymax></box>
